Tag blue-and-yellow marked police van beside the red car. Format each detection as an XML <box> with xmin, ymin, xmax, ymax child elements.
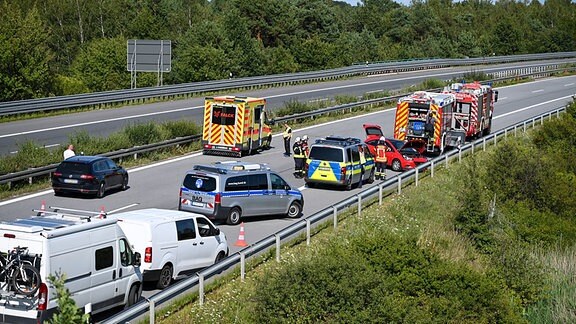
<box><xmin>304</xmin><ymin>136</ymin><xmax>375</xmax><ymax>190</ymax></box>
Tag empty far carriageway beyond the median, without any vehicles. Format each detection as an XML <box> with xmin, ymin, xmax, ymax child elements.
<box><xmin>0</xmin><ymin>59</ymin><xmax>576</xmax><ymax>155</ymax></box>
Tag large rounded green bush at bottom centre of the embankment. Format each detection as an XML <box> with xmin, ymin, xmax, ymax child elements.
<box><xmin>254</xmin><ymin>229</ymin><xmax>521</xmax><ymax>323</ymax></box>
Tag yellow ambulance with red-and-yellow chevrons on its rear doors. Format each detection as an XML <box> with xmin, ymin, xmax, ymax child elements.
<box><xmin>202</xmin><ymin>96</ymin><xmax>272</xmax><ymax>157</ymax></box>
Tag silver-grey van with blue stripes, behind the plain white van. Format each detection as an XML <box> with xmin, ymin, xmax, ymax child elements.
<box><xmin>178</xmin><ymin>161</ymin><xmax>304</xmax><ymax>225</ymax></box>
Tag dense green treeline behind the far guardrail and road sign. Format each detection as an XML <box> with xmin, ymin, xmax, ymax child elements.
<box><xmin>0</xmin><ymin>0</ymin><xmax>576</xmax><ymax>101</ymax></box>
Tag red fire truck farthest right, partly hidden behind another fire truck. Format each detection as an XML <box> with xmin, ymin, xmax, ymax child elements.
<box><xmin>444</xmin><ymin>82</ymin><xmax>498</xmax><ymax>139</ymax></box>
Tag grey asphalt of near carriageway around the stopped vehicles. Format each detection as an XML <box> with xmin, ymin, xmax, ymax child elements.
<box><xmin>0</xmin><ymin>75</ymin><xmax>576</xmax><ymax>318</ymax></box>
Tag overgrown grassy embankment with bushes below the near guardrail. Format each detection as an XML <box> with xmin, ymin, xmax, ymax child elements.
<box><xmin>151</xmin><ymin>103</ymin><xmax>576</xmax><ymax>323</ymax></box>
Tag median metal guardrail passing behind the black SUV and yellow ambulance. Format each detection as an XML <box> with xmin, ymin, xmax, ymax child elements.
<box><xmin>0</xmin><ymin>65</ymin><xmax>576</xmax><ymax>186</ymax></box>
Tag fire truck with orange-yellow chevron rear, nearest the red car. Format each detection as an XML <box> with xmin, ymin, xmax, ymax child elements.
<box><xmin>394</xmin><ymin>91</ymin><xmax>466</xmax><ymax>154</ymax></box>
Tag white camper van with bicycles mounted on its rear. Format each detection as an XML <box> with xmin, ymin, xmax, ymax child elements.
<box><xmin>0</xmin><ymin>207</ymin><xmax>142</xmax><ymax>323</ymax></box>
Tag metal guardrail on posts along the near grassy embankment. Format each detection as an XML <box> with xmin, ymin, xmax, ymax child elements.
<box><xmin>102</xmin><ymin>107</ymin><xmax>566</xmax><ymax>324</ymax></box>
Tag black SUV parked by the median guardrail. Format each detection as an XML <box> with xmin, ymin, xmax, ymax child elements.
<box><xmin>52</xmin><ymin>156</ymin><xmax>128</xmax><ymax>198</ymax></box>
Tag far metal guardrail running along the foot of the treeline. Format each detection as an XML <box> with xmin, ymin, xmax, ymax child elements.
<box><xmin>0</xmin><ymin>52</ymin><xmax>576</xmax><ymax>116</ymax></box>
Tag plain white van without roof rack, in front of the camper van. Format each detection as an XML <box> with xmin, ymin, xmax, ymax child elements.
<box><xmin>108</xmin><ymin>208</ymin><xmax>228</xmax><ymax>289</ymax></box>
